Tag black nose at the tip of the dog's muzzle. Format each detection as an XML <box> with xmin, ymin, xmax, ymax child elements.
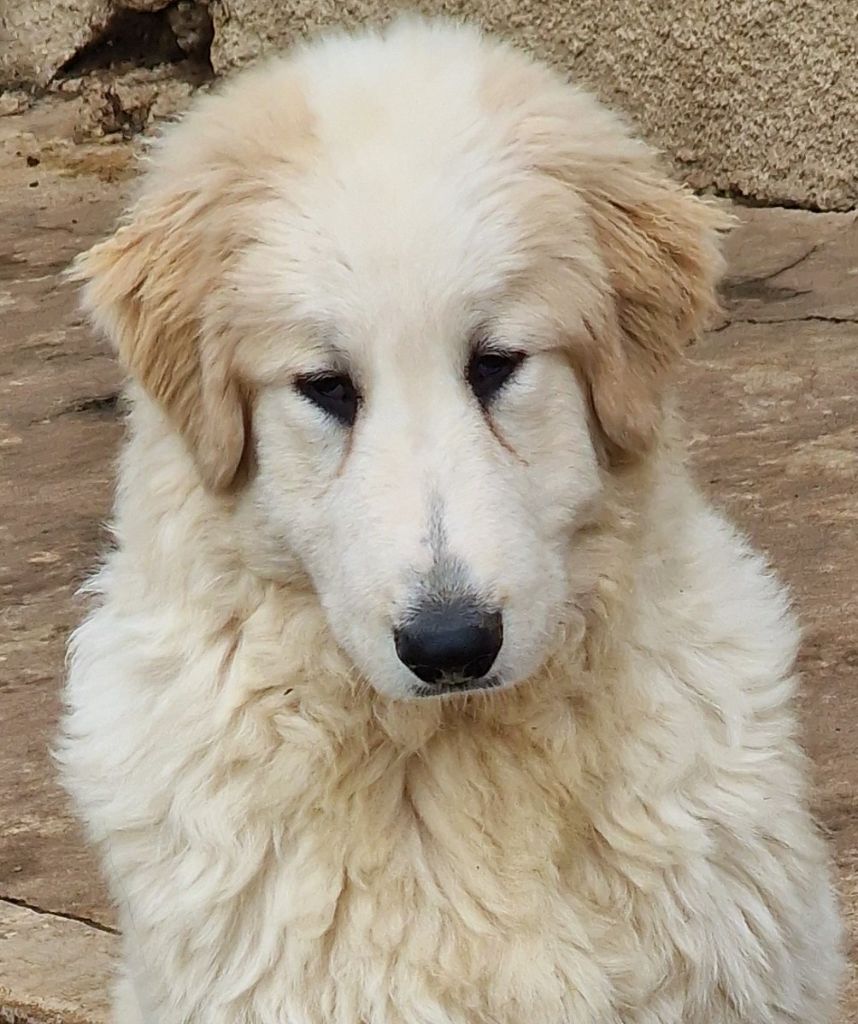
<box><xmin>394</xmin><ymin>601</ymin><xmax>504</xmax><ymax>683</ymax></box>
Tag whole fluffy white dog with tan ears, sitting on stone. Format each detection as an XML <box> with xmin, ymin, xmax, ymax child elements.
<box><xmin>59</xmin><ymin>22</ymin><xmax>841</xmax><ymax>1024</ymax></box>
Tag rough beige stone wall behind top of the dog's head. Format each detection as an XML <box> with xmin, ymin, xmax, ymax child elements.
<box><xmin>0</xmin><ymin>0</ymin><xmax>858</xmax><ymax>210</ymax></box>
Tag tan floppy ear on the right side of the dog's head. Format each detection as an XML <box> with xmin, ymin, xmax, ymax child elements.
<box><xmin>577</xmin><ymin>172</ymin><xmax>730</xmax><ymax>459</ymax></box>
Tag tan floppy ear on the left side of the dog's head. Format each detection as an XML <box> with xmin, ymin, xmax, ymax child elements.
<box><xmin>72</xmin><ymin>182</ymin><xmax>245</xmax><ymax>490</ymax></box>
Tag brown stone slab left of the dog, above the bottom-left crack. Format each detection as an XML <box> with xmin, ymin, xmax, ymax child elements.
<box><xmin>0</xmin><ymin>103</ymin><xmax>130</xmax><ymax>942</ymax></box>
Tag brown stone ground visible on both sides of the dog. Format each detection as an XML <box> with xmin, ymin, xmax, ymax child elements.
<box><xmin>0</xmin><ymin>96</ymin><xmax>858</xmax><ymax>1024</ymax></box>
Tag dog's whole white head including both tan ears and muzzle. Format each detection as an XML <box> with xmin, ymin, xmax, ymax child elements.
<box><xmin>79</xmin><ymin>23</ymin><xmax>724</xmax><ymax>696</ymax></box>
